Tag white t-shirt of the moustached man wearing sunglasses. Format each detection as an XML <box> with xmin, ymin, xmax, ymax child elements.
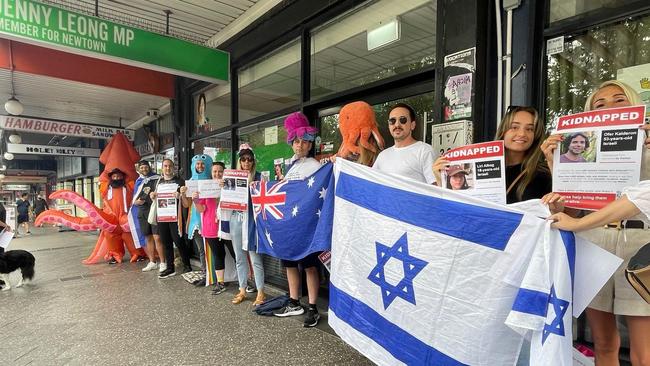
<box><xmin>372</xmin><ymin>141</ymin><xmax>436</xmax><ymax>184</ymax></box>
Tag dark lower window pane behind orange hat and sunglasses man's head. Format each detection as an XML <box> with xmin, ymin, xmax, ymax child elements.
<box><xmin>315</xmin><ymin>92</ymin><xmax>434</xmax><ymax>159</ymax></box>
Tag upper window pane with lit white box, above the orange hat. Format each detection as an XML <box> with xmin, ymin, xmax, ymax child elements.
<box><xmin>311</xmin><ymin>0</ymin><xmax>437</xmax><ymax>98</ymax></box>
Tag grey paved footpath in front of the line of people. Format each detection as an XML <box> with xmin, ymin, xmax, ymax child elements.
<box><xmin>0</xmin><ymin>227</ymin><xmax>371</xmax><ymax>366</ymax></box>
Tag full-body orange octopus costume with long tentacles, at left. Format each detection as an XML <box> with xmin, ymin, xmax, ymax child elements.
<box><xmin>36</xmin><ymin>132</ymin><xmax>145</xmax><ymax>264</ymax></box>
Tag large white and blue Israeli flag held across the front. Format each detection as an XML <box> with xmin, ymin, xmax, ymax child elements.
<box><xmin>329</xmin><ymin>159</ymin><xmax>572</xmax><ymax>365</ymax></box>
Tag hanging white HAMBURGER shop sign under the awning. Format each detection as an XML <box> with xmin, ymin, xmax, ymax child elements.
<box><xmin>0</xmin><ymin>116</ymin><xmax>135</xmax><ymax>141</ymax></box>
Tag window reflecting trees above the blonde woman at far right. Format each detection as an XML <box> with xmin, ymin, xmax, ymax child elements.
<box><xmin>546</xmin><ymin>16</ymin><xmax>650</xmax><ymax>129</ymax></box>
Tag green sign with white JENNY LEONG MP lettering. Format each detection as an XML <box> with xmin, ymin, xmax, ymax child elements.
<box><xmin>0</xmin><ymin>0</ymin><xmax>229</xmax><ymax>83</ymax></box>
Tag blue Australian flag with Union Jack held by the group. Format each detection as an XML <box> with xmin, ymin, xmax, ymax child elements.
<box><xmin>251</xmin><ymin>163</ymin><xmax>334</xmax><ymax>260</ymax></box>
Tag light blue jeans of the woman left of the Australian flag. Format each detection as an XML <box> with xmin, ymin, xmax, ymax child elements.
<box><xmin>230</xmin><ymin>211</ymin><xmax>264</xmax><ymax>291</ymax></box>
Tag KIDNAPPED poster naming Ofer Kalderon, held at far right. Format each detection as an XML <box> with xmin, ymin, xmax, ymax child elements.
<box><xmin>553</xmin><ymin>106</ymin><xmax>645</xmax><ymax>210</ymax></box>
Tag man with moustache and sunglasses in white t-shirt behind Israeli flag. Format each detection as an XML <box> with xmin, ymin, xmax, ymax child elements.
<box><xmin>372</xmin><ymin>103</ymin><xmax>436</xmax><ymax>184</ymax></box>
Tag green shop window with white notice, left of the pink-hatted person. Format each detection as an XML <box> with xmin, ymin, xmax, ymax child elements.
<box><xmin>237</xmin><ymin>116</ymin><xmax>293</xmax><ymax>179</ymax></box>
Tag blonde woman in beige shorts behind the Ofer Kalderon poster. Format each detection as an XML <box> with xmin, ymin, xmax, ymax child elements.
<box><xmin>542</xmin><ymin>80</ymin><xmax>650</xmax><ymax>365</ymax></box>
